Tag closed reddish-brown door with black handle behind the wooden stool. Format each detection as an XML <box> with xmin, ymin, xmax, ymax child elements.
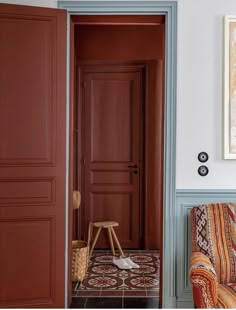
<box><xmin>80</xmin><ymin>65</ymin><xmax>142</xmax><ymax>248</ymax></box>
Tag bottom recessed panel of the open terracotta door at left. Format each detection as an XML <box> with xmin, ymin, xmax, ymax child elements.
<box><xmin>0</xmin><ymin>217</ymin><xmax>56</xmax><ymax>305</ymax></box>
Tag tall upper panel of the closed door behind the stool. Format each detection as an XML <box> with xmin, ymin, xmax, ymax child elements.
<box><xmin>91</xmin><ymin>78</ymin><xmax>133</xmax><ymax>163</ymax></box>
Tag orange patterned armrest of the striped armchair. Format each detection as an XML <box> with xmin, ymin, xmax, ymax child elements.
<box><xmin>189</xmin><ymin>252</ymin><xmax>218</xmax><ymax>308</ymax></box>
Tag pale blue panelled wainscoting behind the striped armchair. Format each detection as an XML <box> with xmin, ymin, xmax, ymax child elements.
<box><xmin>176</xmin><ymin>189</ymin><xmax>236</xmax><ymax>308</ymax></box>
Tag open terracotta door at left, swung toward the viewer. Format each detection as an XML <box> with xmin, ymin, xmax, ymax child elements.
<box><xmin>0</xmin><ymin>4</ymin><xmax>66</xmax><ymax>308</ymax></box>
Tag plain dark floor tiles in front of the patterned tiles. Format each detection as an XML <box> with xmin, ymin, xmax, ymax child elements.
<box><xmin>70</xmin><ymin>297</ymin><xmax>159</xmax><ymax>309</ymax></box>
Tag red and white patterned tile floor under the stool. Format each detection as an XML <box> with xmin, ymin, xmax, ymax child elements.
<box><xmin>73</xmin><ymin>251</ymin><xmax>160</xmax><ymax>297</ymax></box>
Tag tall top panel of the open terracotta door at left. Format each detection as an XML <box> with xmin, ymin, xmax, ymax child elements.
<box><xmin>0</xmin><ymin>17</ymin><xmax>56</xmax><ymax>166</ymax></box>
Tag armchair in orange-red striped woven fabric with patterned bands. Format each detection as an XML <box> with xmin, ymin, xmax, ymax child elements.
<box><xmin>189</xmin><ymin>203</ymin><xmax>236</xmax><ymax>308</ymax></box>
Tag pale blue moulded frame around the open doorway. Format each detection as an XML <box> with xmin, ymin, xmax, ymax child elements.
<box><xmin>58</xmin><ymin>0</ymin><xmax>177</xmax><ymax>308</ymax></box>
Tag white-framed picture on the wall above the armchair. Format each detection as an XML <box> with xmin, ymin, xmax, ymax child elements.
<box><xmin>224</xmin><ymin>16</ymin><xmax>236</xmax><ymax>159</ymax></box>
